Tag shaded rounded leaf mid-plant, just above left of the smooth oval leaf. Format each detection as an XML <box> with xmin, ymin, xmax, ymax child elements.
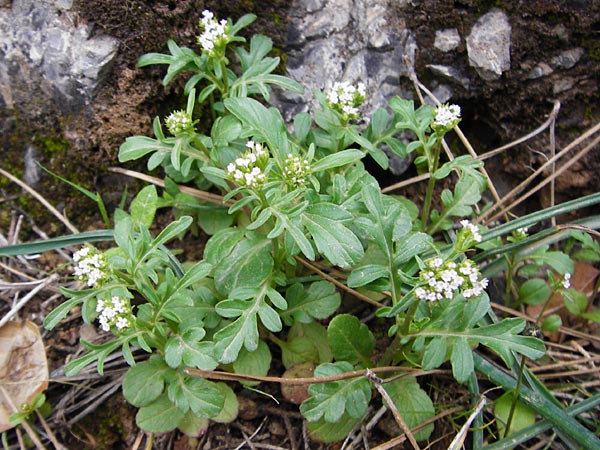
<box><xmin>281</xmin><ymin>280</ymin><xmax>341</xmax><ymax>323</ymax></box>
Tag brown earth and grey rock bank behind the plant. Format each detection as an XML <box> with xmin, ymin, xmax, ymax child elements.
<box><xmin>0</xmin><ymin>0</ymin><xmax>600</xmax><ymax>227</ymax></box>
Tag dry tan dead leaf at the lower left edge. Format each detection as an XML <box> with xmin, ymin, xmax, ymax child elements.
<box><xmin>0</xmin><ymin>320</ymin><xmax>48</xmax><ymax>432</ymax></box>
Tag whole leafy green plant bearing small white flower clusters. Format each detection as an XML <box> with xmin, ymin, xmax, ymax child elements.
<box><xmin>4</xmin><ymin>7</ymin><xmax>600</xmax><ymax>445</ymax></box>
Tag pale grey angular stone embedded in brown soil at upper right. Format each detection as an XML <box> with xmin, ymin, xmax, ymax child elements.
<box><xmin>467</xmin><ymin>8</ymin><xmax>511</xmax><ymax>80</ymax></box>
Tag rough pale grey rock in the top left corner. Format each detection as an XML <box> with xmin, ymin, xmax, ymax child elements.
<box><xmin>0</xmin><ymin>0</ymin><xmax>118</xmax><ymax>113</ymax></box>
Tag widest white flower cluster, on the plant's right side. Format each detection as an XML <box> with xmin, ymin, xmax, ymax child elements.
<box><xmin>415</xmin><ymin>257</ymin><xmax>488</xmax><ymax>302</ymax></box>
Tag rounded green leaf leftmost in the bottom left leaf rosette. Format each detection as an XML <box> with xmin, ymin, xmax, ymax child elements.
<box><xmin>123</xmin><ymin>357</ymin><xmax>172</xmax><ymax>408</ymax></box>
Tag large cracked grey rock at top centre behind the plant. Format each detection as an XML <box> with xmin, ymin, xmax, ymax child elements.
<box><xmin>274</xmin><ymin>0</ymin><xmax>417</xmax><ymax>124</ymax></box>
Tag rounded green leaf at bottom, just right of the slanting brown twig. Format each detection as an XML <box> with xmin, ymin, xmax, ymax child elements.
<box><xmin>383</xmin><ymin>377</ymin><xmax>435</xmax><ymax>441</ymax></box>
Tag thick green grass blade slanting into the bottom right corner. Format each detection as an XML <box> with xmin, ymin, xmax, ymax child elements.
<box><xmin>473</xmin><ymin>353</ymin><xmax>600</xmax><ymax>450</ymax></box>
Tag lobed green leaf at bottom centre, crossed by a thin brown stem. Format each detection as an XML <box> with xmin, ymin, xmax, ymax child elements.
<box><xmin>300</xmin><ymin>361</ymin><xmax>371</xmax><ymax>423</ymax></box>
